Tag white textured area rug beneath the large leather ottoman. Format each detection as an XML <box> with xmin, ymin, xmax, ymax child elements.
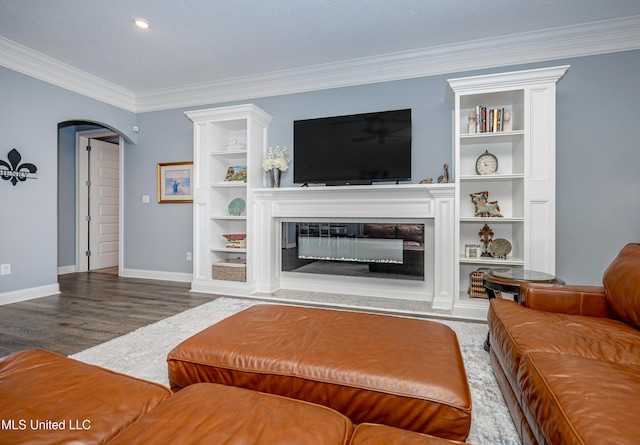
<box><xmin>71</xmin><ymin>297</ymin><xmax>521</xmax><ymax>445</ymax></box>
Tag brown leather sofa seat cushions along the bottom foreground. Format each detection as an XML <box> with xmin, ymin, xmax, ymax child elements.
<box><xmin>0</xmin><ymin>349</ymin><xmax>461</xmax><ymax>445</ymax></box>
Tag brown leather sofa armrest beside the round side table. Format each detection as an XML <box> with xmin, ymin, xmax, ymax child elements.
<box><xmin>520</xmin><ymin>283</ymin><xmax>612</xmax><ymax>318</ymax></box>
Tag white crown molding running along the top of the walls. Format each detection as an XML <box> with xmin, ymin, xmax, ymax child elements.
<box><xmin>0</xmin><ymin>16</ymin><xmax>640</xmax><ymax>112</ymax></box>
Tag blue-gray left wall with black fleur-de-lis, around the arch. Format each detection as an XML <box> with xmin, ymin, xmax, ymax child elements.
<box><xmin>0</xmin><ymin>67</ymin><xmax>136</xmax><ymax>293</ymax></box>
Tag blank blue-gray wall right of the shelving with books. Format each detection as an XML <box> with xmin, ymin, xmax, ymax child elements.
<box><xmin>556</xmin><ymin>51</ymin><xmax>640</xmax><ymax>284</ymax></box>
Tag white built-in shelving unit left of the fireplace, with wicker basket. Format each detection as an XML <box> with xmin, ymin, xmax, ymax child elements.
<box><xmin>186</xmin><ymin>104</ymin><xmax>271</xmax><ymax>295</ymax></box>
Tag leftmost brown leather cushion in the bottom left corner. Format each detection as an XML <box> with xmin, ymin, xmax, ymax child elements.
<box><xmin>0</xmin><ymin>349</ymin><xmax>171</xmax><ymax>445</ymax></box>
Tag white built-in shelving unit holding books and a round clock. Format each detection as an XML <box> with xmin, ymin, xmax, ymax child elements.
<box><xmin>447</xmin><ymin>66</ymin><xmax>569</xmax><ymax>318</ymax></box>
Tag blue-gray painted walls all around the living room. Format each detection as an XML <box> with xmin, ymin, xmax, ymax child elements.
<box><xmin>0</xmin><ymin>51</ymin><xmax>640</xmax><ymax>293</ymax></box>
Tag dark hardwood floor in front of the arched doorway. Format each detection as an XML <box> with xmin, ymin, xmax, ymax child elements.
<box><xmin>0</xmin><ymin>272</ymin><xmax>218</xmax><ymax>357</ymax></box>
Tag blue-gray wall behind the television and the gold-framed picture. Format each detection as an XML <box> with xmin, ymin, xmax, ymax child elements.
<box><xmin>124</xmin><ymin>74</ymin><xmax>452</xmax><ymax>273</ymax></box>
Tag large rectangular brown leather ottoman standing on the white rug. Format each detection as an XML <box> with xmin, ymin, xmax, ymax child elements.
<box><xmin>167</xmin><ymin>304</ymin><xmax>471</xmax><ymax>440</ymax></box>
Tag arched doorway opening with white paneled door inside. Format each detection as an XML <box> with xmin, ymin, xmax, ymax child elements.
<box><xmin>58</xmin><ymin>121</ymin><xmax>124</xmax><ymax>274</ymax></box>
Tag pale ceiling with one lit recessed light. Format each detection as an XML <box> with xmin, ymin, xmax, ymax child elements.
<box><xmin>0</xmin><ymin>0</ymin><xmax>640</xmax><ymax>109</ymax></box>
